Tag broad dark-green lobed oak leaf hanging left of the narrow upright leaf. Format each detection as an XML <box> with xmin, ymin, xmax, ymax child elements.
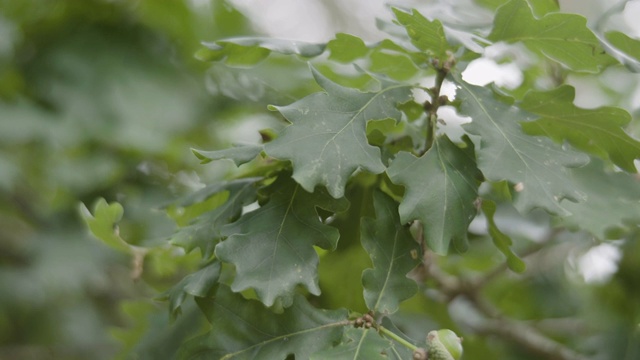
<box><xmin>215</xmin><ymin>176</ymin><xmax>348</xmax><ymax>306</ymax></box>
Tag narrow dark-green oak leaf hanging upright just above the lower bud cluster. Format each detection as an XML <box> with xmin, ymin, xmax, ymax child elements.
<box><xmin>360</xmin><ymin>192</ymin><xmax>422</xmax><ymax>315</ymax></box>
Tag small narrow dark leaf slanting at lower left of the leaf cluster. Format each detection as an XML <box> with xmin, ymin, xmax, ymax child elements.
<box><xmin>159</xmin><ymin>261</ymin><xmax>220</xmax><ymax>318</ymax></box>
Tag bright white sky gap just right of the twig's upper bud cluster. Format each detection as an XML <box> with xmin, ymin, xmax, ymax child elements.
<box><xmin>462</xmin><ymin>58</ymin><xmax>523</xmax><ymax>89</ymax></box>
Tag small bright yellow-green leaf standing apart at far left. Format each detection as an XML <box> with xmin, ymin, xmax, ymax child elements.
<box><xmin>80</xmin><ymin>198</ymin><xmax>133</xmax><ymax>253</ymax></box>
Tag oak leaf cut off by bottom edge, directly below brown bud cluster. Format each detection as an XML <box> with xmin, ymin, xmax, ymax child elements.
<box><xmin>310</xmin><ymin>328</ymin><xmax>393</xmax><ymax>360</ymax></box>
